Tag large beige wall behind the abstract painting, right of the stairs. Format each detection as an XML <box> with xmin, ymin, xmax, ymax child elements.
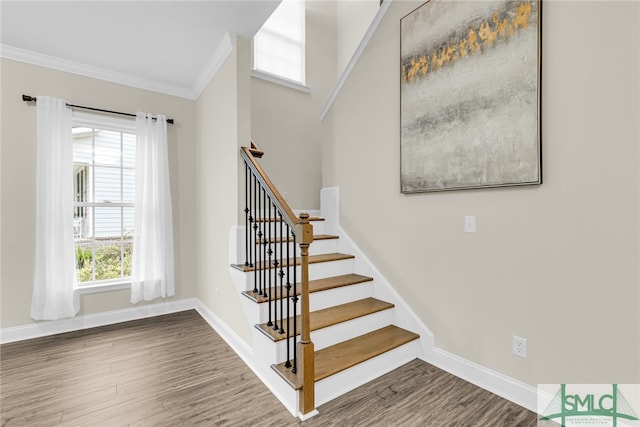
<box><xmin>323</xmin><ymin>1</ymin><xmax>640</xmax><ymax>385</ymax></box>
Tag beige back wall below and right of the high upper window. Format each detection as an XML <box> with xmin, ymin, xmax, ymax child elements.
<box><xmin>251</xmin><ymin>1</ymin><xmax>336</xmax><ymax>209</ymax></box>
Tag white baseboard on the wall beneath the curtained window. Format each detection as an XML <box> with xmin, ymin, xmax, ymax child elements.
<box><xmin>0</xmin><ymin>298</ymin><xmax>199</xmax><ymax>344</ymax></box>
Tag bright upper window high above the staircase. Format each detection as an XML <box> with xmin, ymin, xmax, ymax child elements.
<box><xmin>253</xmin><ymin>0</ymin><xmax>305</xmax><ymax>85</ymax></box>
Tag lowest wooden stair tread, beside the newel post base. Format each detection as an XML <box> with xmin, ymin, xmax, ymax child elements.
<box><xmin>271</xmin><ymin>325</ymin><xmax>420</xmax><ymax>390</ymax></box>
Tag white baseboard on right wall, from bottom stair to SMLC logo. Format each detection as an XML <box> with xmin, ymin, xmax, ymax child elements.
<box><xmin>423</xmin><ymin>348</ymin><xmax>538</xmax><ymax>412</ymax></box>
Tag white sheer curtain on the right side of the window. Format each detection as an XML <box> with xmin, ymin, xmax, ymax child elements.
<box><xmin>131</xmin><ymin>113</ymin><xmax>175</xmax><ymax>304</ymax></box>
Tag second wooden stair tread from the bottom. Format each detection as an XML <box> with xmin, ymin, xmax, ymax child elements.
<box><xmin>256</xmin><ymin>297</ymin><xmax>395</xmax><ymax>341</ymax></box>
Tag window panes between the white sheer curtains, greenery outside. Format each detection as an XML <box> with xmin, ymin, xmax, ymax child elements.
<box><xmin>72</xmin><ymin>123</ymin><xmax>136</xmax><ymax>285</ymax></box>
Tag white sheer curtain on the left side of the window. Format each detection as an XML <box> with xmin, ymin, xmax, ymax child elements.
<box><xmin>31</xmin><ymin>96</ymin><xmax>80</xmax><ymax>320</ymax></box>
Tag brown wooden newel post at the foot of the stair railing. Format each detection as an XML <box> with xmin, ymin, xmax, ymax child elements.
<box><xmin>296</xmin><ymin>213</ymin><xmax>315</xmax><ymax>414</ymax></box>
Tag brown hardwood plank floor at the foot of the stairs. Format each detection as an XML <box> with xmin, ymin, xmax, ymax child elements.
<box><xmin>0</xmin><ymin>310</ymin><xmax>536</xmax><ymax>427</ymax></box>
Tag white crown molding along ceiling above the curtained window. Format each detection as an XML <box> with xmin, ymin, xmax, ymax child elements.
<box><xmin>0</xmin><ymin>44</ymin><xmax>196</xmax><ymax>100</ymax></box>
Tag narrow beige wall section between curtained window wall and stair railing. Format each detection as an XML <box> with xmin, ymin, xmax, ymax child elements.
<box><xmin>195</xmin><ymin>39</ymin><xmax>251</xmax><ymax>342</ymax></box>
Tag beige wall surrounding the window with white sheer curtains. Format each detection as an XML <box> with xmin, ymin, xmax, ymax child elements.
<box><xmin>0</xmin><ymin>58</ymin><xmax>196</xmax><ymax>328</ymax></box>
